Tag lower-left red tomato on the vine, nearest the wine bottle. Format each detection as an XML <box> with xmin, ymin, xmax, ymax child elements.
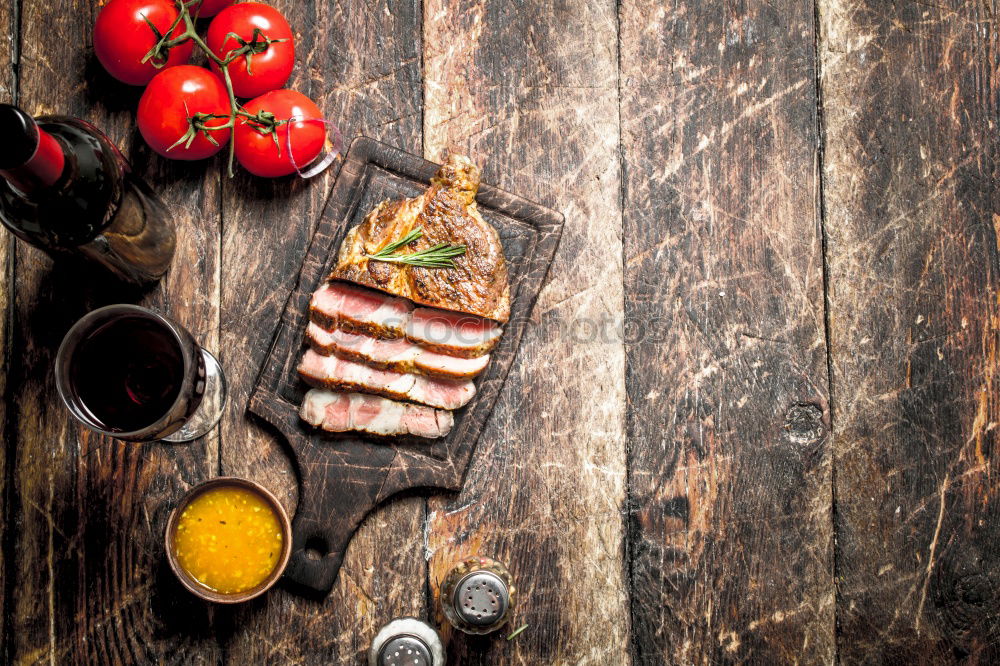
<box><xmin>136</xmin><ymin>65</ymin><xmax>230</xmax><ymax>160</ymax></box>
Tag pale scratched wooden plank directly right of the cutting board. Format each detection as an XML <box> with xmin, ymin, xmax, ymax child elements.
<box><xmin>424</xmin><ymin>0</ymin><xmax>628</xmax><ymax>664</ymax></box>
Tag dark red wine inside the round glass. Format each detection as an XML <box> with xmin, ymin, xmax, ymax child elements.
<box><xmin>69</xmin><ymin>314</ymin><xmax>184</xmax><ymax>432</ymax></box>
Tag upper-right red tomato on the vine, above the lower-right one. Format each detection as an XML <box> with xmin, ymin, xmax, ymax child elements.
<box><xmin>207</xmin><ymin>2</ymin><xmax>295</xmax><ymax>97</ymax></box>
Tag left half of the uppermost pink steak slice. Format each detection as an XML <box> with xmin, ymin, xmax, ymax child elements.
<box><xmin>309</xmin><ymin>282</ymin><xmax>413</xmax><ymax>339</ymax></box>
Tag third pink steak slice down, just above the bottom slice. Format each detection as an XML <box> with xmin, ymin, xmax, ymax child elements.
<box><xmin>298</xmin><ymin>349</ymin><xmax>476</xmax><ymax>409</ymax></box>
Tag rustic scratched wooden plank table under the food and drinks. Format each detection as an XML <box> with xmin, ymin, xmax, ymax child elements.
<box><xmin>0</xmin><ymin>0</ymin><xmax>1000</xmax><ymax>665</ymax></box>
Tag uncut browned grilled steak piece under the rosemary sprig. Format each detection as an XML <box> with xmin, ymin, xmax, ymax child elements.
<box><xmin>330</xmin><ymin>155</ymin><xmax>510</xmax><ymax>323</ymax></box>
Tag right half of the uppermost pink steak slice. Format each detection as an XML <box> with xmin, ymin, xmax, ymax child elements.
<box><xmin>406</xmin><ymin>308</ymin><xmax>503</xmax><ymax>358</ymax></box>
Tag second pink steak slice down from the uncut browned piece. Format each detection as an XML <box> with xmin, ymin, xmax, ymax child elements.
<box><xmin>306</xmin><ymin>322</ymin><xmax>490</xmax><ymax>380</ymax></box>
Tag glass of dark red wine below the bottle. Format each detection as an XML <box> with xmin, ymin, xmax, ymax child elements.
<box><xmin>55</xmin><ymin>305</ymin><xmax>226</xmax><ymax>442</ymax></box>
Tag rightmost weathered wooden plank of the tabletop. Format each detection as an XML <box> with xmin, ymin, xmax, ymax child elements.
<box><xmin>819</xmin><ymin>0</ymin><xmax>1000</xmax><ymax>664</ymax></box>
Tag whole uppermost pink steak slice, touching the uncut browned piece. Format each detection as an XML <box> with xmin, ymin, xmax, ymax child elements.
<box><xmin>309</xmin><ymin>282</ymin><xmax>503</xmax><ymax>358</ymax></box>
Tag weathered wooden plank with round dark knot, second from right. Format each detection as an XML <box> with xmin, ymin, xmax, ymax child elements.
<box><xmin>621</xmin><ymin>1</ymin><xmax>834</xmax><ymax>664</ymax></box>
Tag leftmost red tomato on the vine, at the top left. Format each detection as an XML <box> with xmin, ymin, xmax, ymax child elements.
<box><xmin>94</xmin><ymin>0</ymin><xmax>194</xmax><ymax>86</ymax></box>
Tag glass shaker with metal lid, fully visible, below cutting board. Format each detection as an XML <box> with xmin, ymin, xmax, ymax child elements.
<box><xmin>441</xmin><ymin>557</ymin><xmax>515</xmax><ymax>634</ymax></box>
